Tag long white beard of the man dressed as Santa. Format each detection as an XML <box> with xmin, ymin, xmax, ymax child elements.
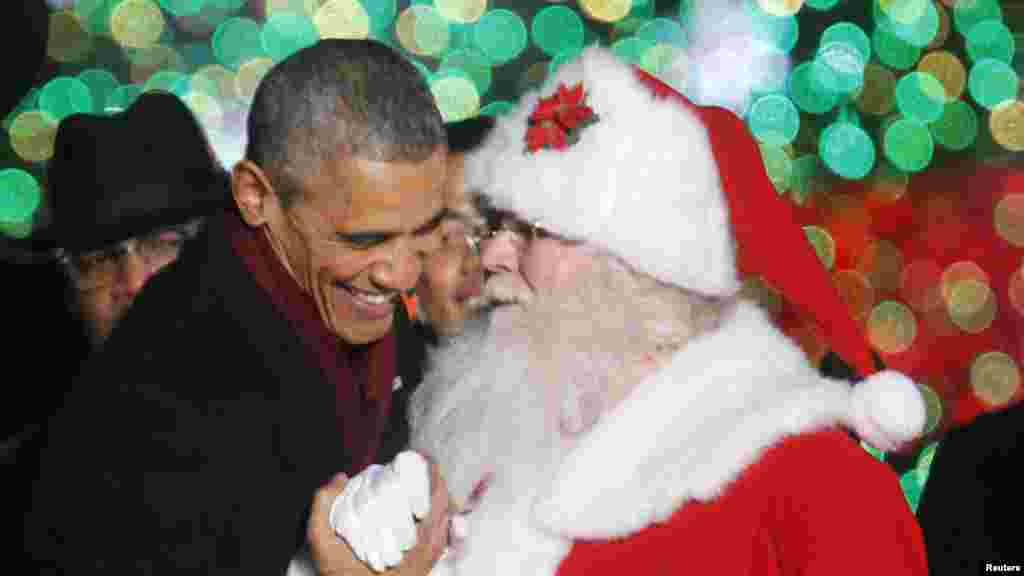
<box><xmin>410</xmin><ymin>261</ymin><xmax>647</xmax><ymax>575</ymax></box>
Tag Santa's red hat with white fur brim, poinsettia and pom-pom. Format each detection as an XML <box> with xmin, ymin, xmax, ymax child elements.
<box><xmin>466</xmin><ymin>46</ymin><xmax>925</xmax><ymax>448</ymax></box>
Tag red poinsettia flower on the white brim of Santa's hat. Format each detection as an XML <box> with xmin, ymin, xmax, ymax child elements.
<box><xmin>526</xmin><ymin>83</ymin><xmax>597</xmax><ymax>152</ymax></box>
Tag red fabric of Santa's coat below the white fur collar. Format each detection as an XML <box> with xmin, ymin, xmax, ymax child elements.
<box><xmin>558</xmin><ymin>430</ymin><xmax>928</xmax><ymax>576</ymax></box>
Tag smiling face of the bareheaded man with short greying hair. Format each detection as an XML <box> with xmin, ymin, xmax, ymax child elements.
<box><xmin>258</xmin><ymin>149</ymin><xmax>445</xmax><ymax>344</ymax></box>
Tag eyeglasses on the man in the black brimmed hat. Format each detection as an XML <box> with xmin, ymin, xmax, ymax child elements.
<box><xmin>57</xmin><ymin>219</ymin><xmax>202</xmax><ymax>292</ymax></box>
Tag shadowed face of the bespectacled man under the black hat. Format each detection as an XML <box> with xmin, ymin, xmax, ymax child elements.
<box><xmin>60</xmin><ymin>220</ymin><xmax>200</xmax><ymax>347</ymax></box>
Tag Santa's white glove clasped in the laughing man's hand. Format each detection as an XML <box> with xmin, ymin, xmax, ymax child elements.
<box><xmin>330</xmin><ymin>451</ymin><xmax>430</xmax><ymax>572</ymax></box>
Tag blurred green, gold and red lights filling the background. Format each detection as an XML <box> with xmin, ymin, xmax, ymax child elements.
<box><xmin>0</xmin><ymin>0</ymin><xmax>1024</xmax><ymax>494</ymax></box>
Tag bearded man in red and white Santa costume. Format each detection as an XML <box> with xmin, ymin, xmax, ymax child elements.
<box><xmin>311</xmin><ymin>47</ymin><xmax>927</xmax><ymax>576</ymax></box>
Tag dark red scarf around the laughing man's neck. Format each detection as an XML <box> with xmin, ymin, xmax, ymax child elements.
<box><xmin>227</xmin><ymin>214</ymin><xmax>396</xmax><ymax>475</ymax></box>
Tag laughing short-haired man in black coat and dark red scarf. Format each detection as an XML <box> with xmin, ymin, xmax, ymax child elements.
<box><xmin>25</xmin><ymin>40</ymin><xmax>445</xmax><ymax>574</ymax></box>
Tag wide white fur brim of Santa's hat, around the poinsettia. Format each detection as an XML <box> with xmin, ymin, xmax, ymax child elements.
<box><xmin>466</xmin><ymin>46</ymin><xmax>739</xmax><ymax>295</ymax></box>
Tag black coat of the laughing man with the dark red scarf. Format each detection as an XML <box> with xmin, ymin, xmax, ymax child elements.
<box><xmin>25</xmin><ymin>208</ymin><xmax>422</xmax><ymax>575</ymax></box>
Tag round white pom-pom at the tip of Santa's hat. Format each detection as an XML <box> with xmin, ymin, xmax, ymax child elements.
<box><xmin>847</xmin><ymin>370</ymin><xmax>926</xmax><ymax>452</ymax></box>
